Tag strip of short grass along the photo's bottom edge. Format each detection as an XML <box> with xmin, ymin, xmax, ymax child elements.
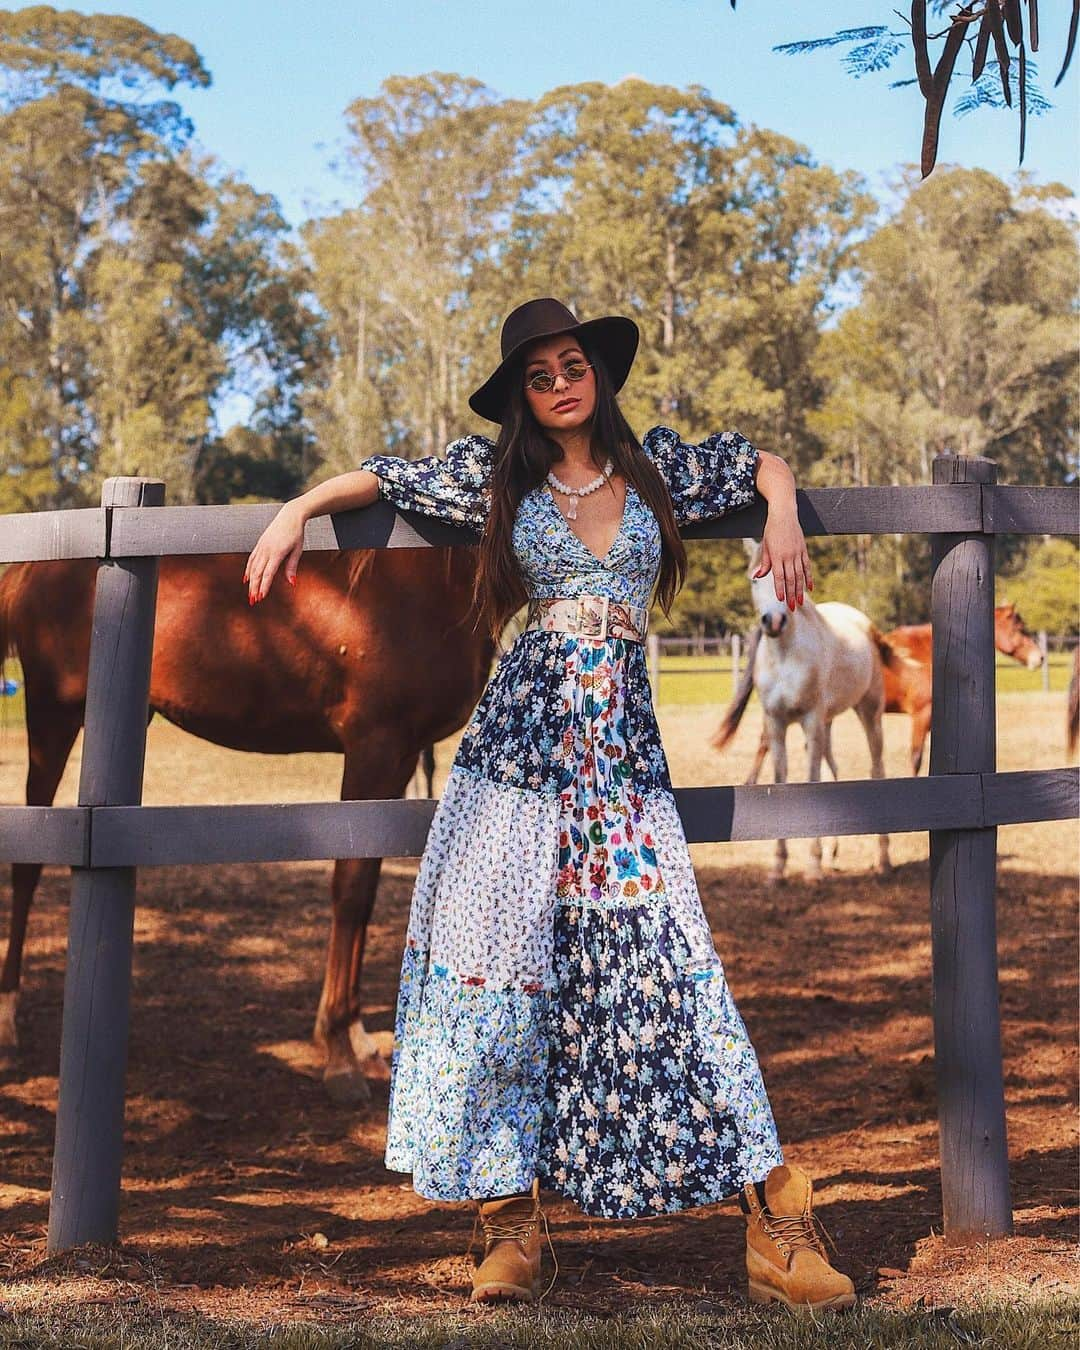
<box><xmin>0</xmin><ymin>1299</ymin><xmax>1080</xmax><ymax>1350</ymax></box>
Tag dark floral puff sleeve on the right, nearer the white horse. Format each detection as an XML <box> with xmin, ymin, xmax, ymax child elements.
<box><xmin>641</xmin><ymin>427</ymin><xmax>759</xmax><ymax>525</ymax></box>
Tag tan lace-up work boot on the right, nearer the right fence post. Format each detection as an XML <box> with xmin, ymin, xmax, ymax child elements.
<box><xmin>743</xmin><ymin>1164</ymin><xmax>855</xmax><ymax>1312</ymax></box>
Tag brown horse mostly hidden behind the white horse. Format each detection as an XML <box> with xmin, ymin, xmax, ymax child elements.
<box><xmin>729</xmin><ymin>605</ymin><xmax>1042</xmax><ymax>783</ymax></box>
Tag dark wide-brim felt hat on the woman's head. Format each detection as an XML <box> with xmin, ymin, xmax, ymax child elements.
<box><xmin>468</xmin><ymin>297</ymin><xmax>639</xmax><ymax>423</ymax></box>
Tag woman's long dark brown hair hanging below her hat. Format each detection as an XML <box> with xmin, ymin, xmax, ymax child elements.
<box><xmin>473</xmin><ymin>343</ymin><xmax>686</xmax><ymax>643</ymax></box>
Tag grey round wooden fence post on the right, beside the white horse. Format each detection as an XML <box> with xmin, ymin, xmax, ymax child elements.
<box><xmin>930</xmin><ymin>455</ymin><xmax>1013</xmax><ymax>1243</ymax></box>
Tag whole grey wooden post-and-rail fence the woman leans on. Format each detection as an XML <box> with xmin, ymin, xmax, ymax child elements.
<box><xmin>0</xmin><ymin>456</ymin><xmax>1080</xmax><ymax>1251</ymax></box>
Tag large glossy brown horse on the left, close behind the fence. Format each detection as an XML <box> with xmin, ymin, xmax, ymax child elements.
<box><xmin>0</xmin><ymin>547</ymin><xmax>494</xmax><ymax>1102</ymax></box>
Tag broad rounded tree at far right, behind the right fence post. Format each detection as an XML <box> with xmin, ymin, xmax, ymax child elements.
<box><xmin>806</xmin><ymin>169</ymin><xmax>1077</xmax><ymax>624</ymax></box>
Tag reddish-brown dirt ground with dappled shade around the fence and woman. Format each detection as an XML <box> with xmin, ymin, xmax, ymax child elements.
<box><xmin>0</xmin><ymin>694</ymin><xmax>1079</xmax><ymax>1323</ymax></box>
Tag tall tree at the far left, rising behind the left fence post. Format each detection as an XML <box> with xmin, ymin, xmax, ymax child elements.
<box><xmin>0</xmin><ymin>5</ymin><xmax>311</xmax><ymax>506</ymax></box>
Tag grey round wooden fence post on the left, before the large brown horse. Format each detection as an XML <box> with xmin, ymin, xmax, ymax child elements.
<box><xmin>47</xmin><ymin>478</ymin><xmax>165</xmax><ymax>1253</ymax></box>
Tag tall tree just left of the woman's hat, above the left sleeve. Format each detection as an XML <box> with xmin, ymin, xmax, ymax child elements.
<box><xmin>304</xmin><ymin>73</ymin><xmax>524</xmax><ymax>473</ymax></box>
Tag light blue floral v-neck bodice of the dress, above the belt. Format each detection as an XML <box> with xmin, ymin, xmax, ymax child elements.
<box><xmin>512</xmin><ymin>482</ymin><xmax>660</xmax><ymax>605</ymax></box>
